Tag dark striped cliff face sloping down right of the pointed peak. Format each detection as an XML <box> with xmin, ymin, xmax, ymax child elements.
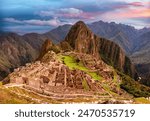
<box><xmin>99</xmin><ymin>38</ymin><xmax>137</xmax><ymax>78</ymax></box>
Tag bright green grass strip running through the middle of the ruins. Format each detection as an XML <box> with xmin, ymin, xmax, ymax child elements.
<box><xmin>58</xmin><ymin>55</ymin><xmax>102</xmax><ymax>80</ymax></box>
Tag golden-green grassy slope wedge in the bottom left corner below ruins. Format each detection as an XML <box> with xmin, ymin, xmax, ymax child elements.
<box><xmin>0</xmin><ymin>82</ymin><xmax>58</xmax><ymax>104</ymax></box>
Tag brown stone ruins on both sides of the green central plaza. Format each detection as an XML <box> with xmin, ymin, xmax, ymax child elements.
<box><xmin>4</xmin><ymin>51</ymin><xmax>118</xmax><ymax>93</ymax></box>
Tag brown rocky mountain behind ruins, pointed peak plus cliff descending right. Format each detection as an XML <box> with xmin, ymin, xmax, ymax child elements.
<box><xmin>65</xmin><ymin>21</ymin><xmax>136</xmax><ymax>78</ymax></box>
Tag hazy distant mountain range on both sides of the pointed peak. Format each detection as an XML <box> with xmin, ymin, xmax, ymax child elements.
<box><xmin>0</xmin><ymin>21</ymin><xmax>150</xmax><ymax>84</ymax></box>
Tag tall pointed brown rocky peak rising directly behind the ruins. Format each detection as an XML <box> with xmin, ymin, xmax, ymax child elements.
<box><xmin>65</xmin><ymin>21</ymin><xmax>99</xmax><ymax>58</ymax></box>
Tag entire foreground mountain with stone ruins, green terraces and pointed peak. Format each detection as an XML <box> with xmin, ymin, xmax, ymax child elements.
<box><xmin>0</xmin><ymin>21</ymin><xmax>150</xmax><ymax>103</ymax></box>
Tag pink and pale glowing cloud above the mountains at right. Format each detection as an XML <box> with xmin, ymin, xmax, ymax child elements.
<box><xmin>96</xmin><ymin>8</ymin><xmax>150</xmax><ymax>28</ymax></box>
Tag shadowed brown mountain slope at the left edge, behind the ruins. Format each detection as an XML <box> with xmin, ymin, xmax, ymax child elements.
<box><xmin>0</xmin><ymin>33</ymin><xmax>37</xmax><ymax>79</ymax></box>
